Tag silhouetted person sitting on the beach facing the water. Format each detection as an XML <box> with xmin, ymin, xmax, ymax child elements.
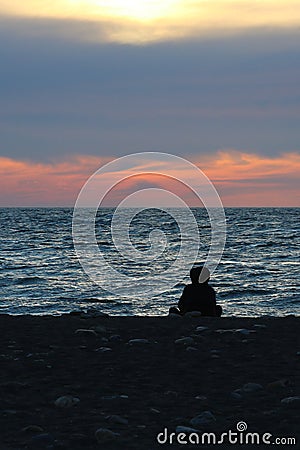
<box><xmin>169</xmin><ymin>267</ymin><xmax>222</xmax><ymax>317</ymax></box>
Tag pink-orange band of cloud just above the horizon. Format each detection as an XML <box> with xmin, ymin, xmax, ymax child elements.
<box><xmin>0</xmin><ymin>150</ymin><xmax>300</xmax><ymax>206</ymax></box>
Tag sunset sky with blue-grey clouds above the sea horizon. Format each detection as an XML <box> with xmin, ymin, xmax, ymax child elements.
<box><xmin>0</xmin><ymin>0</ymin><xmax>300</xmax><ymax>206</ymax></box>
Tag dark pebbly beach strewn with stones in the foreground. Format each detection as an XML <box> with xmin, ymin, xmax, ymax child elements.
<box><xmin>0</xmin><ymin>315</ymin><xmax>300</xmax><ymax>450</ymax></box>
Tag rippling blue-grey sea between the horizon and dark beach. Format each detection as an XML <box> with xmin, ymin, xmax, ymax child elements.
<box><xmin>0</xmin><ymin>208</ymin><xmax>300</xmax><ymax>317</ymax></box>
